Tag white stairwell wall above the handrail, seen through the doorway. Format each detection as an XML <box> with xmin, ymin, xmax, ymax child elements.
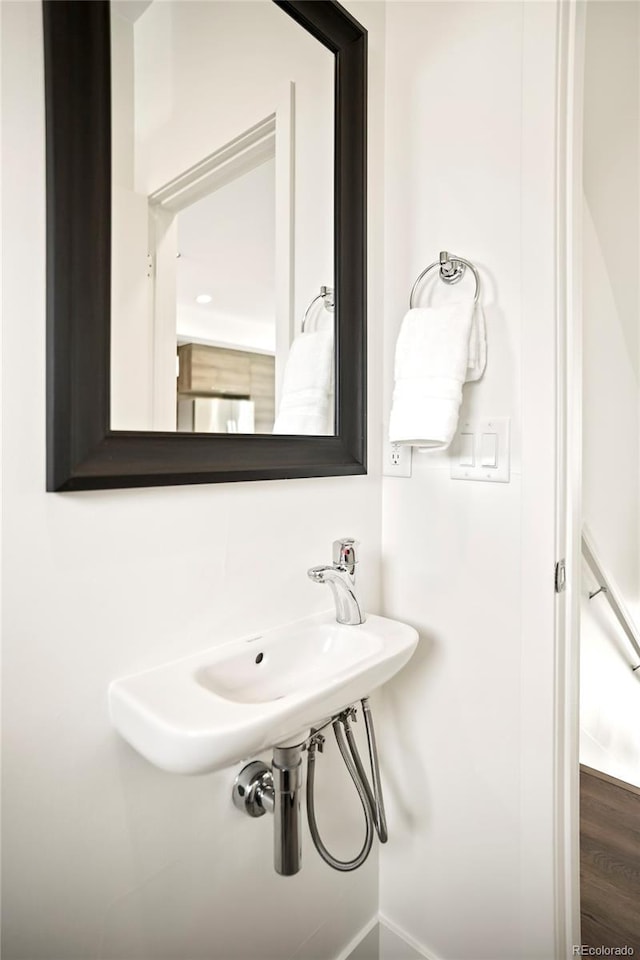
<box><xmin>583</xmin><ymin>0</ymin><xmax>640</xmax><ymax>600</ymax></box>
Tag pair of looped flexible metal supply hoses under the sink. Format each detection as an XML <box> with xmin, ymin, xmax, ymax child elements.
<box><xmin>307</xmin><ymin>699</ymin><xmax>388</xmax><ymax>872</ymax></box>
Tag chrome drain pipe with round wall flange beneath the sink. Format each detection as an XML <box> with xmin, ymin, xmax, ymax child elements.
<box><xmin>232</xmin><ymin>745</ymin><xmax>302</xmax><ymax>877</ymax></box>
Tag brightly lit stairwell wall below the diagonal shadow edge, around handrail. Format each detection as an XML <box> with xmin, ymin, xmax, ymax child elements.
<box><xmin>580</xmin><ymin>201</ymin><xmax>640</xmax><ymax>786</ymax></box>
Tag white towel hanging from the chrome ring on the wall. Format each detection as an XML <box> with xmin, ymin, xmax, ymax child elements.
<box><xmin>389</xmin><ymin>302</ymin><xmax>478</xmax><ymax>450</ymax></box>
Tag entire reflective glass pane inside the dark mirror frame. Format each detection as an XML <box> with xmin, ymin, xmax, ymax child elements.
<box><xmin>111</xmin><ymin>0</ymin><xmax>335</xmax><ymax>435</ymax></box>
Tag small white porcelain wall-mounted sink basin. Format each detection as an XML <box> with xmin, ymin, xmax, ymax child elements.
<box><xmin>109</xmin><ymin>611</ymin><xmax>418</xmax><ymax>773</ymax></box>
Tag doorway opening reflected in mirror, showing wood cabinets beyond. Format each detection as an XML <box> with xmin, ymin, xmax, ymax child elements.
<box><xmin>174</xmin><ymin>158</ymin><xmax>276</xmax><ymax>433</ymax></box>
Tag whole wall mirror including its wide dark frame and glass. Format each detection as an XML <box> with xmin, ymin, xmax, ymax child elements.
<box><xmin>43</xmin><ymin>0</ymin><xmax>367</xmax><ymax>491</ymax></box>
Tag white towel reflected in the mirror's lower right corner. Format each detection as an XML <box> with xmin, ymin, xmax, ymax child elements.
<box><xmin>273</xmin><ymin>329</ymin><xmax>334</xmax><ymax>436</ymax></box>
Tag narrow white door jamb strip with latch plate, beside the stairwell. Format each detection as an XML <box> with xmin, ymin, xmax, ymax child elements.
<box><xmin>556</xmin><ymin>0</ymin><xmax>586</xmax><ymax>957</ymax></box>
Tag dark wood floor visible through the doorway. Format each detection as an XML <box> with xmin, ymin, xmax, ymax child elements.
<box><xmin>580</xmin><ymin>766</ymin><xmax>640</xmax><ymax>957</ymax></box>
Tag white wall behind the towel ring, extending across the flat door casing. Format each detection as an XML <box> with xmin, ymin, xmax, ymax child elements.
<box><xmin>380</xmin><ymin>2</ymin><xmax>557</xmax><ymax>960</ymax></box>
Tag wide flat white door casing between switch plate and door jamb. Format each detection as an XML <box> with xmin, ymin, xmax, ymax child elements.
<box><xmin>518</xmin><ymin>2</ymin><xmax>566</xmax><ymax>960</ymax></box>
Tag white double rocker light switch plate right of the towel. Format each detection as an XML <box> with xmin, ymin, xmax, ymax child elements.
<box><xmin>449</xmin><ymin>417</ymin><xmax>511</xmax><ymax>483</ymax></box>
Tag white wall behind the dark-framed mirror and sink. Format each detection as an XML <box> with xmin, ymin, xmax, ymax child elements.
<box><xmin>1</xmin><ymin>2</ymin><xmax>384</xmax><ymax>960</ymax></box>
